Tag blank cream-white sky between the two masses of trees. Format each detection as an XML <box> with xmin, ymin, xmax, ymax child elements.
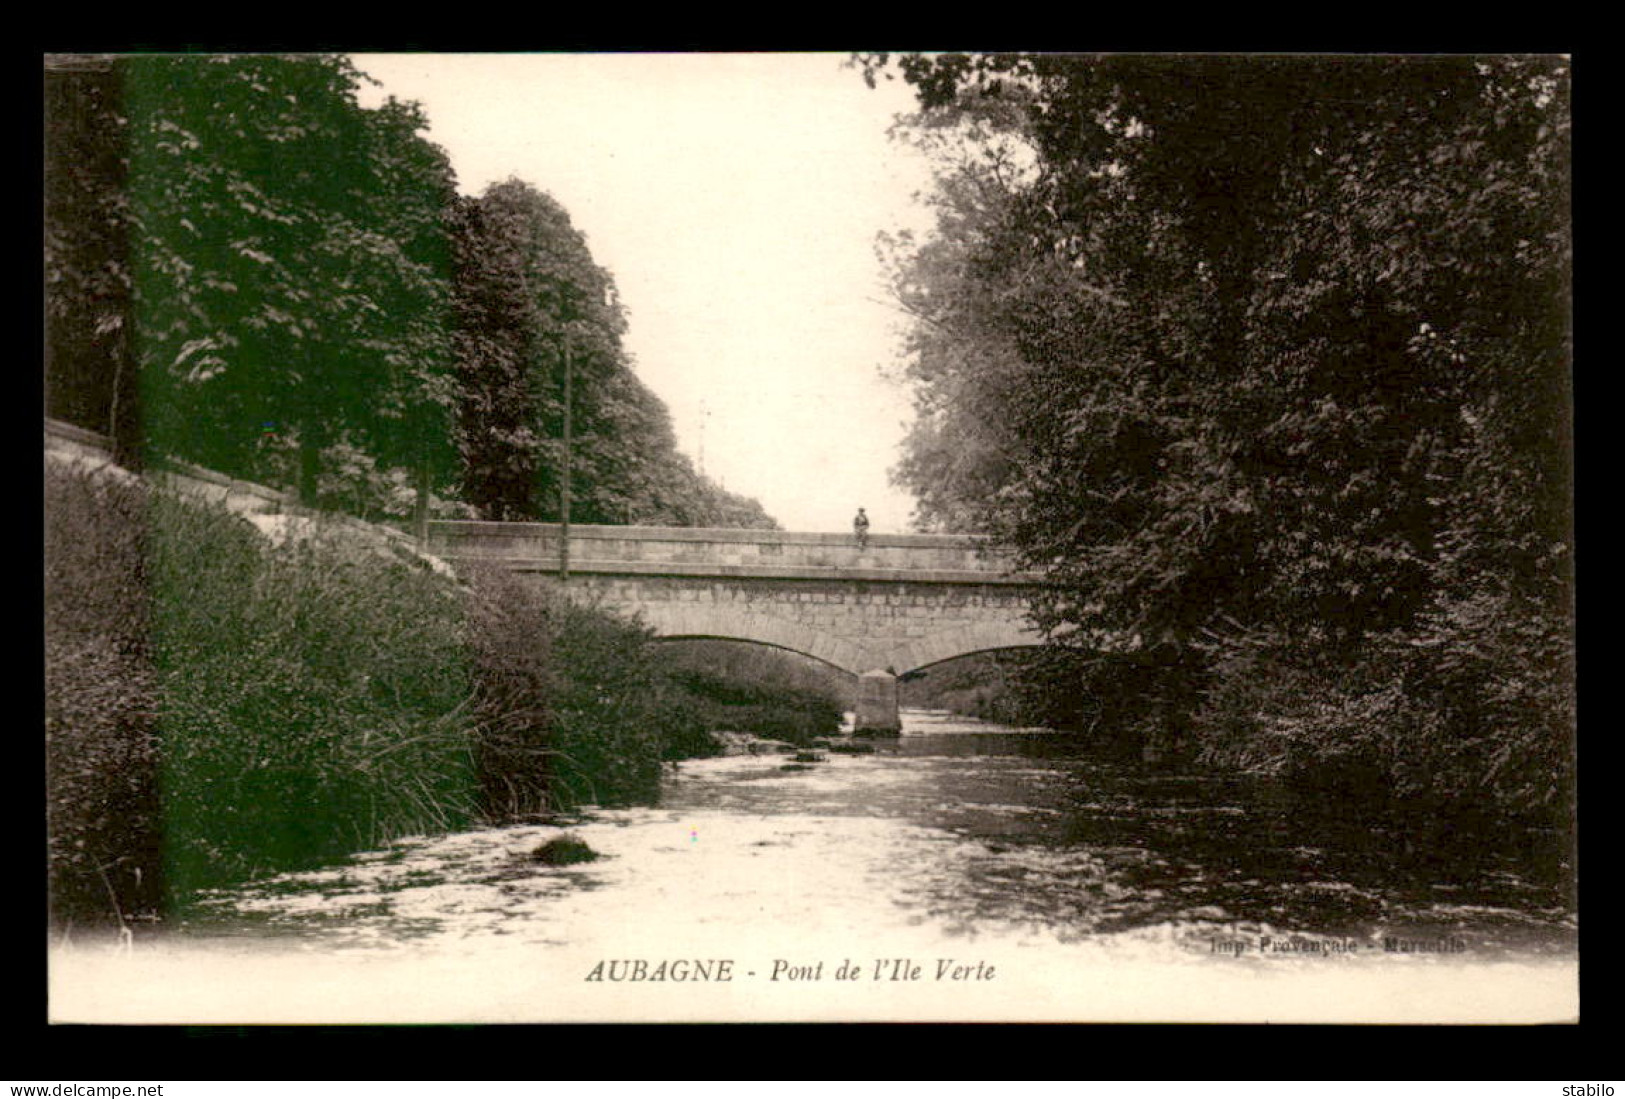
<box><xmin>354</xmin><ymin>54</ymin><xmax>928</xmax><ymax>533</ymax></box>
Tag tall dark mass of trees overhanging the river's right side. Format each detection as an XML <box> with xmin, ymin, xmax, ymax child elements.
<box><xmin>861</xmin><ymin>55</ymin><xmax>1575</xmax><ymax>816</ymax></box>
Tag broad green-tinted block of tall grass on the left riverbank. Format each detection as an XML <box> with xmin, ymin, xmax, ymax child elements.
<box><xmin>148</xmin><ymin>493</ymin><xmax>476</xmax><ymax>899</ymax></box>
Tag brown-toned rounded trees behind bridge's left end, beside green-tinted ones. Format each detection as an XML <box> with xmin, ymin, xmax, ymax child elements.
<box><xmin>453</xmin><ymin>180</ymin><xmax>775</xmax><ymax>527</ymax></box>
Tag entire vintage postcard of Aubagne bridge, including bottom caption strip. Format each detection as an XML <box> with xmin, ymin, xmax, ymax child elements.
<box><xmin>44</xmin><ymin>52</ymin><xmax>1580</xmax><ymax>1024</ymax></box>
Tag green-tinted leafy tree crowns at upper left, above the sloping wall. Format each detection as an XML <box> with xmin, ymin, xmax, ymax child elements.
<box><xmin>91</xmin><ymin>55</ymin><xmax>452</xmax><ymax>501</ymax></box>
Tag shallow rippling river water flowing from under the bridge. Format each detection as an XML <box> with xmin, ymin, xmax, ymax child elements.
<box><xmin>174</xmin><ymin>712</ymin><xmax>1576</xmax><ymax>954</ymax></box>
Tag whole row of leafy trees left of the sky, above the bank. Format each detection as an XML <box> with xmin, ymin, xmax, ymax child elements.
<box><xmin>46</xmin><ymin>54</ymin><xmax>774</xmax><ymax>527</ymax></box>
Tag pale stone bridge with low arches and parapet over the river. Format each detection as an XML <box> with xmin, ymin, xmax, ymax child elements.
<box><xmin>429</xmin><ymin>522</ymin><xmax>1043</xmax><ymax>732</ymax></box>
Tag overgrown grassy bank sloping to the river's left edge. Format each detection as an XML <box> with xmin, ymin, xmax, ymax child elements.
<box><xmin>46</xmin><ymin>460</ymin><xmax>839</xmax><ymax>925</ymax></box>
